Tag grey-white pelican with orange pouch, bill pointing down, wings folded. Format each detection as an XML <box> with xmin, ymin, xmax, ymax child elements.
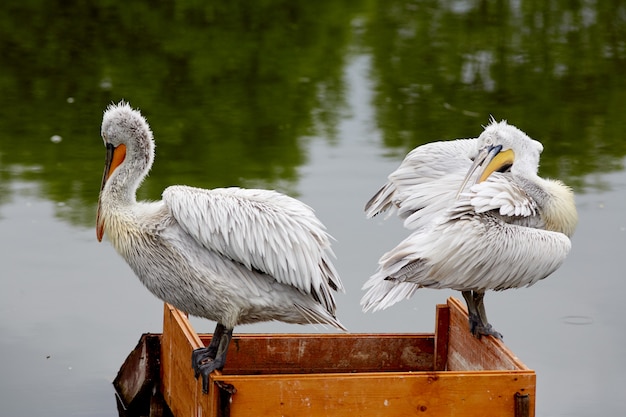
<box><xmin>96</xmin><ymin>101</ymin><xmax>345</xmax><ymax>393</ymax></box>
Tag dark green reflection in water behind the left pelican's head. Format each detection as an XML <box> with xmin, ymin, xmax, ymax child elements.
<box><xmin>0</xmin><ymin>1</ymin><xmax>355</xmax><ymax>224</ymax></box>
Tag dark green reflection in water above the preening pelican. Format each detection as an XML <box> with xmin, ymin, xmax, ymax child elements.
<box><xmin>366</xmin><ymin>1</ymin><xmax>626</xmax><ymax>186</ymax></box>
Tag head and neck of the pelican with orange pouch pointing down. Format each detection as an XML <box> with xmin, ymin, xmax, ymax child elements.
<box><xmin>96</xmin><ymin>101</ymin><xmax>154</xmax><ymax>241</ymax></box>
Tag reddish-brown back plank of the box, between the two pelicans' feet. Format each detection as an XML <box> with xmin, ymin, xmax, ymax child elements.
<box><xmin>201</xmin><ymin>333</ymin><xmax>434</xmax><ymax>375</ymax></box>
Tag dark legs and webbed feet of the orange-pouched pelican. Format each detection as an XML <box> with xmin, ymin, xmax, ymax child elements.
<box><xmin>191</xmin><ymin>323</ymin><xmax>233</xmax><ymax>394</ymax></box>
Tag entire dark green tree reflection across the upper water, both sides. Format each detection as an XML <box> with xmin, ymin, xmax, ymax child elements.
<box><xmin>0</xmin><ymin>0</ymin><xmax>626</xmax><ymax>225</ymax></box>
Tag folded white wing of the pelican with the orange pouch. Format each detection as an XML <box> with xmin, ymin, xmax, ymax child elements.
<box><xmin>163</xmin><ymin>186</ymin><xmax>343</xmax><ymax>312</ymax></box>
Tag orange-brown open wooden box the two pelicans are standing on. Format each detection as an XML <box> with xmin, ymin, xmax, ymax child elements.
<box><xmin>161</xmin><ymin>298</ymin><xmax>536</xmax><ymax>417</ymax></box>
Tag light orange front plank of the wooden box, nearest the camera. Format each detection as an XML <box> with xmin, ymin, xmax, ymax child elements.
<box><xmin>215</xmin><ymin>371</ymin><xmax>535</xmax><ymax>417</ymax></box>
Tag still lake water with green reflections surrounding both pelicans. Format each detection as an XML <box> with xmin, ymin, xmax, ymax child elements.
<box><xmin>0</xmin><ymin>1</ymin><xmax>626</xmax><ymax>417</ymax></box>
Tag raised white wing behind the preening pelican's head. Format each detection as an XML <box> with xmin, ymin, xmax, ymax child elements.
<box><xmin>365</xmin><ymin>139</ymin><xmax>478</xmax><ymax>224</ymax></box>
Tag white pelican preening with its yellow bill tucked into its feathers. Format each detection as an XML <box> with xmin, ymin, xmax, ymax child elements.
<box><xmin>361</xmin><ymin>119</ymin><xmax>578</xmax><ymax>338</ymax></box>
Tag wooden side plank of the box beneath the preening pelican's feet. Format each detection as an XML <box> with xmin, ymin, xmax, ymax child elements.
<box><xmin>447</xmin><ymin>297</ymin><xmax>529</xmax><ymax>371</ymax></box>
